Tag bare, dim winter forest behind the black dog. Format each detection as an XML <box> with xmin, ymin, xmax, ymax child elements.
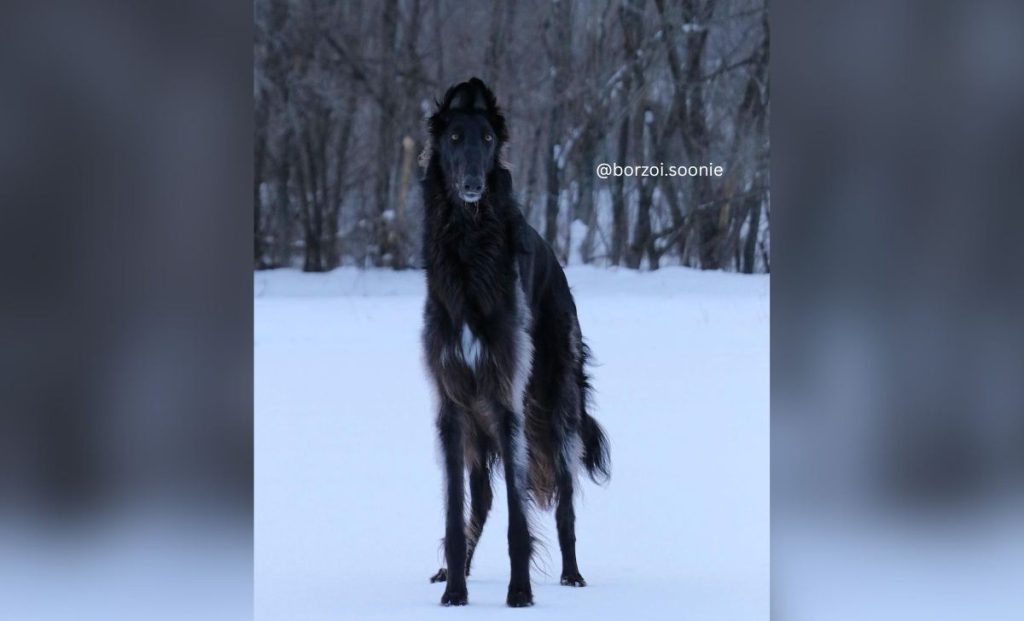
<box><xmin>253</xmin><ymin>0</ymin><xmax>770</xmax><ymax>273</ymax></box>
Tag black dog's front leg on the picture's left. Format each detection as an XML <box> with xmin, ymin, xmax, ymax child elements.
<box><xmin>437</xmin><ymin>400</ymin><xmax>468</xmax><ymax>606</ymax></box>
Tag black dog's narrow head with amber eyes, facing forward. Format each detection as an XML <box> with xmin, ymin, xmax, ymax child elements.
<box><xmin>428</xmin><ymin>78</ymin><xmax>508</xmax><ymax>203</ymax></box>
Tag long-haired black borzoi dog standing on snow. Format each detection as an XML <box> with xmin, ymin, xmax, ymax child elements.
<box><xmin>423</xmin><ymin>78</ymin><xmax>609</xmax><ymax>607</ymax></box>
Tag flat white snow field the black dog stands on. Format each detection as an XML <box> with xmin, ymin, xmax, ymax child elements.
<box><xmin>254</xmin><ymin>267</ymin><xmax>769</xmax><ymax>621</ymax></box>
